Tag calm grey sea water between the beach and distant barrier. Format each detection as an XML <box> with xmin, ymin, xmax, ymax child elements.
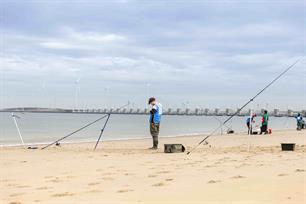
<box><xmin>0</xmin><ymin>113</ymin><xmax>296</xmax><ymax>146</ymax></box>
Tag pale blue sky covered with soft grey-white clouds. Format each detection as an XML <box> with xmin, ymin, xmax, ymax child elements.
<box><xmin>0</xmin><ymin>0</ymin><xmax>306</xmax><ymax>110</ymax></box>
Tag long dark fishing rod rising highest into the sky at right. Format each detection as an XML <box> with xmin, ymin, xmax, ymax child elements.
<box><xmin>187</xmin><ymin>59</ymin><xmax>300</xmax><ymax>155</ymax></box>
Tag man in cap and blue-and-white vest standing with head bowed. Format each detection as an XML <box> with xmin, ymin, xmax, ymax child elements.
<box><xmin>149</xmin><ymin>97</ymin><xmax>162</xmax><ymax>149</ymax></box>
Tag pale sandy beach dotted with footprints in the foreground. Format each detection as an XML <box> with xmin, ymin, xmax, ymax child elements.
<box><xmin>0</xmin><ymin>130</ymin><xmax>306</xmax><ymax>204</ymax></box>
